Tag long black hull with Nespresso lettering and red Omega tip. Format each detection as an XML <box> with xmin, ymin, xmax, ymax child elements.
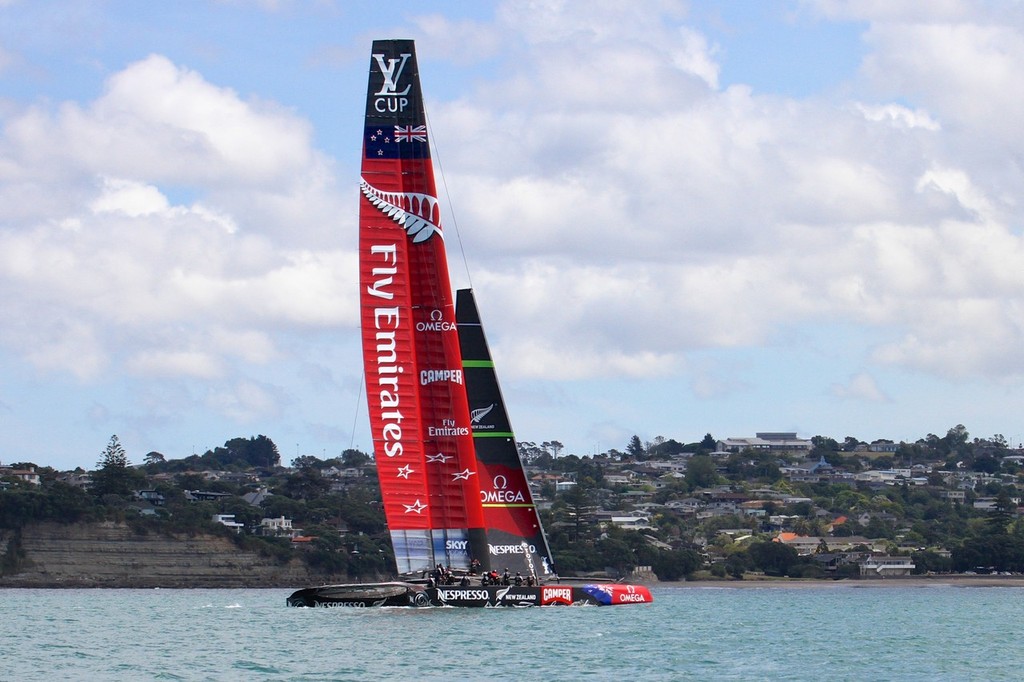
<box><xmin>288</xmin><ymin>583</ymin><xmax>653</xmax><ymax>608</ymax></box>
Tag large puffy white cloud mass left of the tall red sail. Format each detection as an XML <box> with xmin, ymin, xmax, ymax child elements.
<box><xmin>0</xmin><ymin>55</ymin><xmax>354</xmax><ymax>379</ymax></box>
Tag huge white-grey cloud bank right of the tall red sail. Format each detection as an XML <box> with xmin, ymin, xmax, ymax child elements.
<box><xmin>425</xmin><ymin>3</ymin><xmax>1024</xmax><ymax>387</ymax></box>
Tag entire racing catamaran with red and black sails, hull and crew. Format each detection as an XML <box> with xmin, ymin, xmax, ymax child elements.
<box><xmin>288</xmin><ymin>40</ymin><xmax>652</xmax><ymax>607</ymax></box>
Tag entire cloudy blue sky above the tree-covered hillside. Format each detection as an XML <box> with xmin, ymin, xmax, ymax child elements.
<box><xmin>0</xmin><ymin>0</ymin><xmax>1024</xmax><ymax>469</ymax></box>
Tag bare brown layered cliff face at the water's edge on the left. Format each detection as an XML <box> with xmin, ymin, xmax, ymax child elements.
<box><xmin>0</xmin><ymin>522</ymin><xmax>345</xmax><ymax>588</ymax></box>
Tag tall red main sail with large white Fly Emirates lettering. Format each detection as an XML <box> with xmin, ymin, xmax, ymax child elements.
<box><xmin>359</xmin><ymin>40</ymin><xmax>487</xmax><ymax>573</ymax></box>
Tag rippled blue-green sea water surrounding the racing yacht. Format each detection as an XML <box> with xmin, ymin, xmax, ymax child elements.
<box><xmin>0</xmin><ymin>585</ymin><xmax>1024</xmax><ymax>681</ymax></box>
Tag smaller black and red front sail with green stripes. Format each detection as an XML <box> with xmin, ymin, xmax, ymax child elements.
<box><xmin>456</xmin><ymin>289</ymin><xmax>554</xmax><ymax>579</ymax></box>
